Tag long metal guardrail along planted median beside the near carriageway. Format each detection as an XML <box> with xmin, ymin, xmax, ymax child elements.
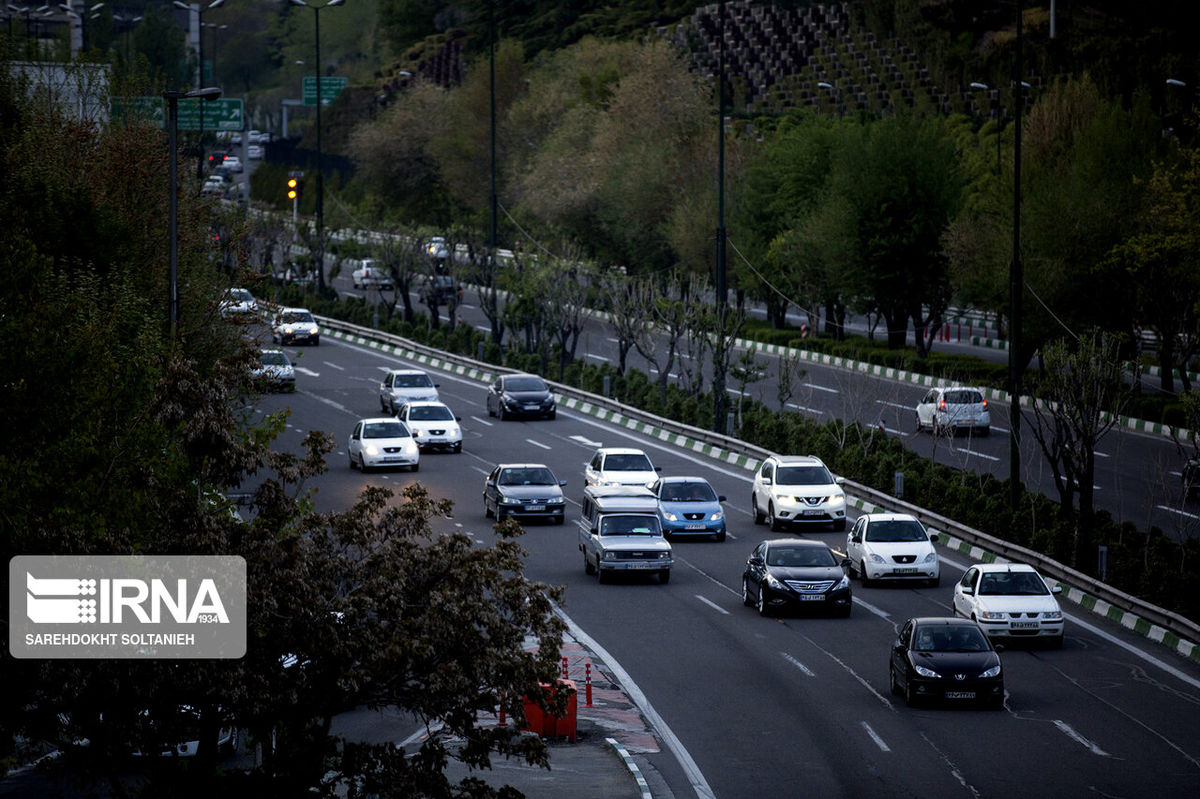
<box><xmin>318</xmin><ymin>317</ymin><xmax>1200</xmax><ymax>656</ymax></box>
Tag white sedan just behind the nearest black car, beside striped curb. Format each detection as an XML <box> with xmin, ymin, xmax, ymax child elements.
<box><xmin>954</xmin><ymin>563</ymin><xmax>1064</xmax><ymax>648</ymax></box>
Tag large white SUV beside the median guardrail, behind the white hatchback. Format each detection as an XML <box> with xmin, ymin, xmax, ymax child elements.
<box><xmin>750</xmin><ymin>455</ymin><xmax>846</xmax><ymax>530</ymax></box>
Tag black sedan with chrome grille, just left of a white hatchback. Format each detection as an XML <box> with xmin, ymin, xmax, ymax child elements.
<box><xmin>742</xmin><ymin>539</ymin><xmax>853</xmax><ymax>615</ymax></box>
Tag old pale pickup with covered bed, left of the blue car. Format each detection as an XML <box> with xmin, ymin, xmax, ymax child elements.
<box><xmin>580</xmin><ymin>486</ymin><xmax>674</xmax><ymax>583</ymax></box>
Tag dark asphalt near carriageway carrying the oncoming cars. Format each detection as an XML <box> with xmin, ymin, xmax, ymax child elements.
<box><xmin>259</xmin><ymin>326</ymin><xmax>1200</xmax><ymax>797</ymax></box>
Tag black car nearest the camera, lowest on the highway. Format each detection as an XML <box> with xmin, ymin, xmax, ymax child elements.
<box><xmin>888</xmin><ymin>618</ymin><xmax>1004</xmax><ymax>710</ymax></box>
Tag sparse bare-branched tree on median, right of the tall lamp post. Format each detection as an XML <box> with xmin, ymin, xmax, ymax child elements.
<box><xmin>1014</xmin><ymin>330</ymin><xmax>1133</xmax><ymax>570</ymax></box>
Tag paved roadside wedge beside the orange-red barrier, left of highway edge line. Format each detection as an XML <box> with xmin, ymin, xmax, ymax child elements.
<box><xmin>446</xmin><ymin>633</ymin><xmax>672</xmax><ymax>799</ymax></box>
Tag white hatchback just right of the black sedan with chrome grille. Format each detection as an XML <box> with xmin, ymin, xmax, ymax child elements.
<box><xmin>846</xmin><ymin>513</ymin><xmax>942</xmax><ymax>587</ymax></box>
